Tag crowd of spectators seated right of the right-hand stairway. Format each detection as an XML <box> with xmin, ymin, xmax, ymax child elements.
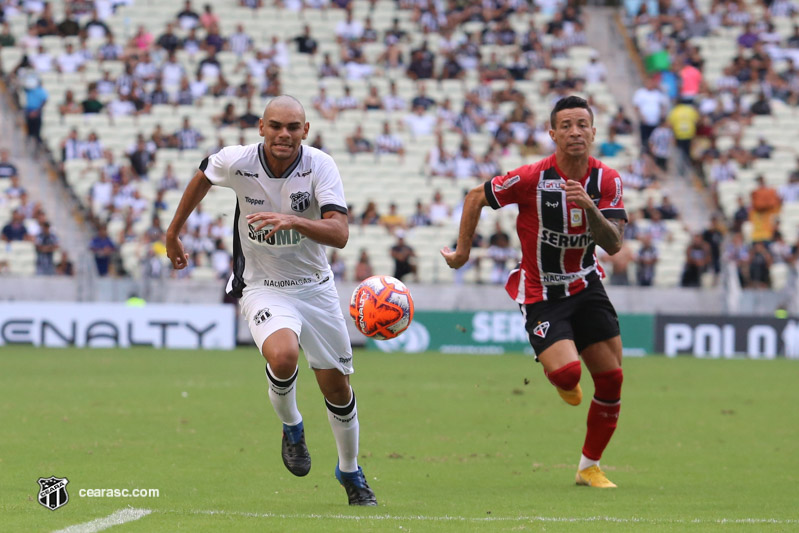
<box><xmin>628</xmin><ymin>0</ymin><xmax>799</xmax><ymax>288</ymax></box>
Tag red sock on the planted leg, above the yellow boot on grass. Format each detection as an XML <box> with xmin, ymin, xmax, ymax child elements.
<box><xmin>580</xmin><ymin>367</ymin><xmax>624</xmax><ymax>461</ymax></box>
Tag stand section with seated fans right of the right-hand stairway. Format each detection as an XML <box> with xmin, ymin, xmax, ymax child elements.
<box><xmin>626</xmin><ymin>0</ymin><xmax>799</xmax><ymax>289</ymax></box>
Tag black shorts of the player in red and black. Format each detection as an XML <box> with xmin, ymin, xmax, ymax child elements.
<box><xmin>520</xmin><ymin>281</ymin><xmax>620</xmax><ymax>361</ymax></box>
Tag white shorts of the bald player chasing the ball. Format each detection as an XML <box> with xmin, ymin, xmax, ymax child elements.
<box><xmin>240</xmin><ymin>280</ymin><xmax>354</xmax><ymax>375</ymax></box>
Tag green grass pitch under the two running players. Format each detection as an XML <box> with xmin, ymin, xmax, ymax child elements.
<box><xmin>0</xmin><ymin>346</ymin><xmax>799</xmax><ymax>533</ymax></box>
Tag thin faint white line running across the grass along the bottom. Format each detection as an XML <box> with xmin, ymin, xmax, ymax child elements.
<box><xmin>164</xmin><ymin>510</ymin><xmax>799</xmax><ymax>525</ymax></box>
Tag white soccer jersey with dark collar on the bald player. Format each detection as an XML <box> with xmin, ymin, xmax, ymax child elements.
<box><xmin>200</xmin><ymin>143</ymin><xmax>347</xmax><ymax>297</ymax></box>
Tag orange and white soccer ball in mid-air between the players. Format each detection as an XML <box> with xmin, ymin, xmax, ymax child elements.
<box><xmin>350</xmin><ymin>276</ymin><xmax>413</xmax><ymax>341</ymax></box>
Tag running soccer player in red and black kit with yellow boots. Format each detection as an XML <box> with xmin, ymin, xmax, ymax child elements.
<box><xmin>441</xmin><ymin>96</ymin><xmax>627</xmax><ymax>488</ymax></box>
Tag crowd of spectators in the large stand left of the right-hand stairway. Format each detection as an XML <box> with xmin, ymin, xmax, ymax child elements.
<box><xmin>0</xmin><ymin>0</ymin><xmax>604</xmax><ymax>282</ymax></box>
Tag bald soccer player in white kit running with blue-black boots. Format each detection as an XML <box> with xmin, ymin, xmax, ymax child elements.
<box><xmin>166</xmin><ymin>95</ymin><xmax>377</xmax><ymax>505</ymax></box>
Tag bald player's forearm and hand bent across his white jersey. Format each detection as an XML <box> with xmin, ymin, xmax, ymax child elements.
<box><xmin>247</xmin><ymin>211</ymin><xmax>350</xmax><ymax>248</ymax></box>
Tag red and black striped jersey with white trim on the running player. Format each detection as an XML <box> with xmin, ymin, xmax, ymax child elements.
<box><xmin>485</xmin><ymin>155</ymin><xmax>627</xmax><ymax>304</ymax></box>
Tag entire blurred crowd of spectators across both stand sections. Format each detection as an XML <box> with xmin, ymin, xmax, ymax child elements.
<box><xmin>0</xmin><ymin>0</ymin><xmax>799</xmax><ymax>285</ymax></box>
